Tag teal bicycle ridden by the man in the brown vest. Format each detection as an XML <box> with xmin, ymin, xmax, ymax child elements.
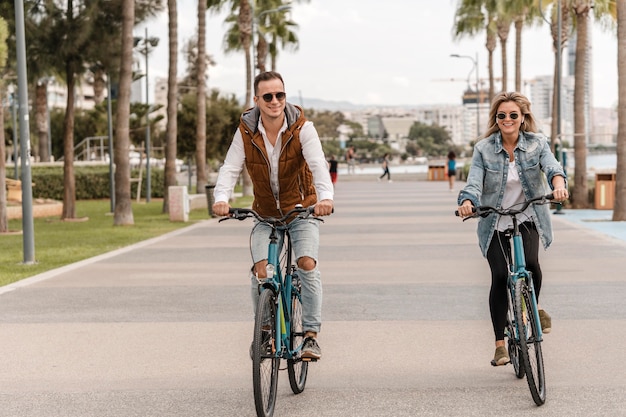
<box><xmin>220</xmin><ymin>206</ymin><xmax>316</xmax><ymax>417</ymax></box>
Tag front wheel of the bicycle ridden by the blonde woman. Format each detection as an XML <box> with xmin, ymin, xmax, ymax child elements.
<box><xmin>515</xmin><ymin>279</ymin><xmax>546</xmax><ymax>405</ymax></box>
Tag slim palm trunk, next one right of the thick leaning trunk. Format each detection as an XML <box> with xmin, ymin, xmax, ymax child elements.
<box><xmin>163</xmin><ymin>0</ymin><xmax>178</xmax><ymax>213</ymax></box>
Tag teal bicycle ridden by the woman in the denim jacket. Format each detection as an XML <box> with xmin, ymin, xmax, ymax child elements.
<box><xmin>456</xmin><ymin>194</ymin><xmax>554</xmax><ymax>405</ymax></box>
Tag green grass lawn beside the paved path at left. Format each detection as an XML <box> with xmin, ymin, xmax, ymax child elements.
<box><xmin>0</xmin><ymin>198</ymin><xmax>251</xmax><ymax>286</ymax></box>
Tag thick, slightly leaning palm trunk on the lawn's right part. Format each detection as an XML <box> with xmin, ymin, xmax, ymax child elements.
<box><xmin>113</xmin><ymin>0</ymin><xmax>135</xmax><ymax>226</ymax></box>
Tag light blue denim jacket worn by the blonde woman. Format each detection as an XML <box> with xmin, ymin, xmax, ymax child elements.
<box><xmin>458</xmin><ymin>132</ymin><xmax>567</xmax><ymax>257</ymax></box>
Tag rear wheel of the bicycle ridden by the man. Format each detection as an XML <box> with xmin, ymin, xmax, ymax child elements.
<box><xmin>287</xmin><ymin>275</ymin><xmax>309</xmax><ymax>394</ymax></box>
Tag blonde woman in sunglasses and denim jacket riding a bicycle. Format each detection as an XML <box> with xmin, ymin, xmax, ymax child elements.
<box><xmin>458</xmin><ymin>92</ymin><xmax>569</xmax><ymax>365</ymax></box>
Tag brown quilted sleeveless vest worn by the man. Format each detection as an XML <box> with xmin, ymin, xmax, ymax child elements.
<box><xmin>239</xmin><ymin>103</ymin><xmax>317</xmax><ymax>217</ymax></box>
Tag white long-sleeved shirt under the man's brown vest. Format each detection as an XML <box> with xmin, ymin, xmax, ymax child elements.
<box><xmin>213</xmin><ymin>118</ymin><xmax>333</xmax><ymax>202</ymax></box>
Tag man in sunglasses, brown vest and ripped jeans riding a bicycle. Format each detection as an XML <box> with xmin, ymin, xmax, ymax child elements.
<box><xmin>213</xmin><ymin>71</ymin><xmax>333</xmax><ymax>360</ymax></box>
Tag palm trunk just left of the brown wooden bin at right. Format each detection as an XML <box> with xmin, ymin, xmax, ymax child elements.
<box><xmin>572</xmin><ymin>9</ymin><xmax>589</xmax><ymax>208</ymax></box>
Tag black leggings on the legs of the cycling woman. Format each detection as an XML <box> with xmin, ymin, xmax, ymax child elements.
<box><xmin>487</xmin><ymin>222</ymin><xmax>542</xmax><ymax>340</ymax></box>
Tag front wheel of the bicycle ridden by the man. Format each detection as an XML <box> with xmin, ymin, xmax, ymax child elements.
<box><xmin>252</xmin><ymin>289</ymin><xmax>280</xmax><ymax>417</ymax></box>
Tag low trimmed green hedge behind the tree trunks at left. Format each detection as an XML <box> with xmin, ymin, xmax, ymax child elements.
<box><xmin>6</xmin><ymin>165</ymin><xmax>165</xmax><ymax>200</ymax></box>
